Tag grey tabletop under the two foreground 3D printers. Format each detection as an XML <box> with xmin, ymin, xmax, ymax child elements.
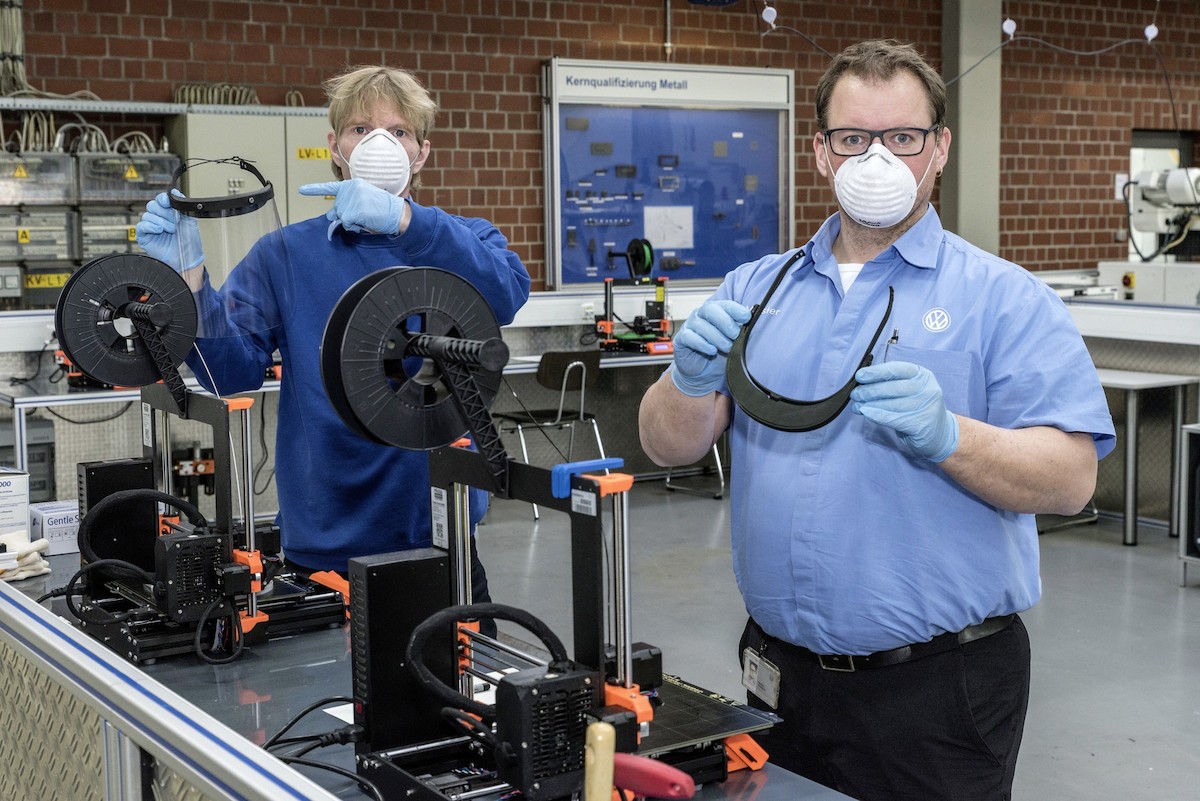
<box><xmin>12</xmin><ymin>554</ymin><xmax>848</xmax><ymax>801</ymax></box>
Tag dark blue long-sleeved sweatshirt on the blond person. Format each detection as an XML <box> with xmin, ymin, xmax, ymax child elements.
<box><xmin>187</xmin><ymin>203</ymin><xmax>529</xmax><ymax>571</ymax></box>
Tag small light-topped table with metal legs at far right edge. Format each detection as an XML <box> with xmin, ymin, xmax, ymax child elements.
<box><xmin>1096</xmin><ymin>367</ymin><xmax>1200</xmax><ymax>546</ymax></box>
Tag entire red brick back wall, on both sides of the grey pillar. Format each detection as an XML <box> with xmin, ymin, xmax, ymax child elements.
<box><xmin>5</xmin><ymin>0</ymin><xmax>1200</xmax><ymax>289</ymax></box>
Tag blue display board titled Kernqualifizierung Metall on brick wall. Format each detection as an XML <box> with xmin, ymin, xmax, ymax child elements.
<box><xmin>546</xmin><ymin>59</ymin><xmax>794</xmax><ymax>289</ymax></box>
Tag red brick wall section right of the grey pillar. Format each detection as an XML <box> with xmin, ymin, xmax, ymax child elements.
<box><xmin>1000</xmin><ymin>0</ymin><xmax>1200</xmax><ymax>270</ymax></box>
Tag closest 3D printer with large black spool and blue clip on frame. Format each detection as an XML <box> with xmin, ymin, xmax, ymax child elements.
<box><xmin>322</xmin><ymin>263</ymin><xmax>776</xmax><ymax>801</ymax></box>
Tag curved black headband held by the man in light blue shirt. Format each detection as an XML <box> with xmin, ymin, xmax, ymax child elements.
<box><xmin>725</xmin><ymin>251</ymin><xmax>895</xmax><ymax>432</ymax></box>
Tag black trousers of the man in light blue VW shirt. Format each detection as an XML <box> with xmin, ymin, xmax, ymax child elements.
<box><xmin>738</xmin><ymin>618</ymin><xmax>1030</xmax><ymax>801</ymax></box>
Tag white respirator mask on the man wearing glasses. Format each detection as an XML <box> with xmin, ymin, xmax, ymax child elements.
<box><xmin>835</xmin><ymin>143</ymin><xmax>916</xmax><ymax>228</ymax></box>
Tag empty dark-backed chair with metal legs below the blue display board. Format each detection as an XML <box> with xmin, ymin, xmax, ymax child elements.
<box><xmin>493</xmin><ymin>348</ymin><xmax>607</xmax><ymax>520</ymax></box>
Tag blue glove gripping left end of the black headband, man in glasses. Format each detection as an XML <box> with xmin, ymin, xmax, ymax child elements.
<box><xmin>671</xmin><ymin>300</ymin><xmax>750</xmax><ymax>397</ymax></box>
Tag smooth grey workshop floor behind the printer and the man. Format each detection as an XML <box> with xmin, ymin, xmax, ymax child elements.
<box><xmin>478</xmin><ymin>477</ymin><xmax>1200</xmax><ymax>801</ymax></box>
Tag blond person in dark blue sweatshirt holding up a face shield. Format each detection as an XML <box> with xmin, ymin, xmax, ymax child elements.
<box><xmin>137</xmin><ymin>66</ymin><xmax>529</xmax><ymax>601</ymax></box>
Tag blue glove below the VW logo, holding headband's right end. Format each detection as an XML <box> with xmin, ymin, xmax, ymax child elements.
<box><xmin>850</xmin><ymin>362</ymin><xmax>959</xmax><ymax>462</ymax></box>
